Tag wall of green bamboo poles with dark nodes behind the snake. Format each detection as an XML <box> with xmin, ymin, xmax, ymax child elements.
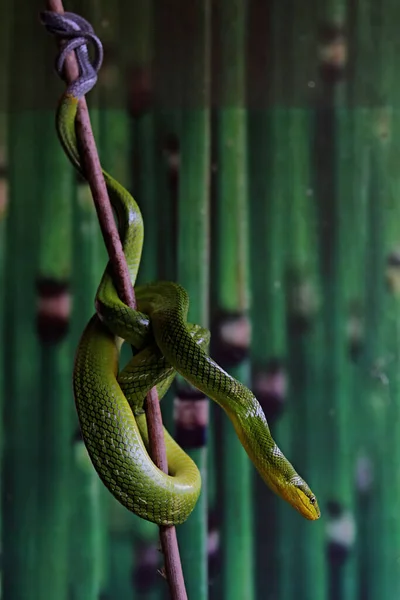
<box><xmin>0</xmin><ymin>0</ymin><xmax>400</xmax><ymax>600</ymax></box>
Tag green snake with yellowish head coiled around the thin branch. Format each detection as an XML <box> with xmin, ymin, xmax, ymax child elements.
<box><xmin>43</xmin><ymin>9</ymin><xmax>320</xmax><ymax>525</ymax></box>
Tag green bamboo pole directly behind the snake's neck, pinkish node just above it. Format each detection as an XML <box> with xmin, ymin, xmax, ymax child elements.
<box><xmin>247</xmin><ymin>3</ymin><xmax>288</xmax><ymax>600</ymax></box>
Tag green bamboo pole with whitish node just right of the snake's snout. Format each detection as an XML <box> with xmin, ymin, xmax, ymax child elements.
<box><xmin>315</xmin><ymin>0</ymin><xmax>355</xmax><ymax>598</ymax></box>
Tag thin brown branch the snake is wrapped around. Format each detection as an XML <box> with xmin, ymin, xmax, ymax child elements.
<box><xmin>46</xmin><ymin>0</ymin><xmax>187</xmax><ymax>600</ymax></box>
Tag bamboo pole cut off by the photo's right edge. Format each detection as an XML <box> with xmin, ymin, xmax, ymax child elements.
<box><xmin>365</xmin><ymin>0</ymin><xmax>400</xmax><ymax>598</ymax></box>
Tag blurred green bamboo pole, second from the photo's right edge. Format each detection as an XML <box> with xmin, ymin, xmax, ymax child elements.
<box><xmin>348</xmin><ymin>2</ymin><xmax>387</xmax><ymax>600</ymax></box>
